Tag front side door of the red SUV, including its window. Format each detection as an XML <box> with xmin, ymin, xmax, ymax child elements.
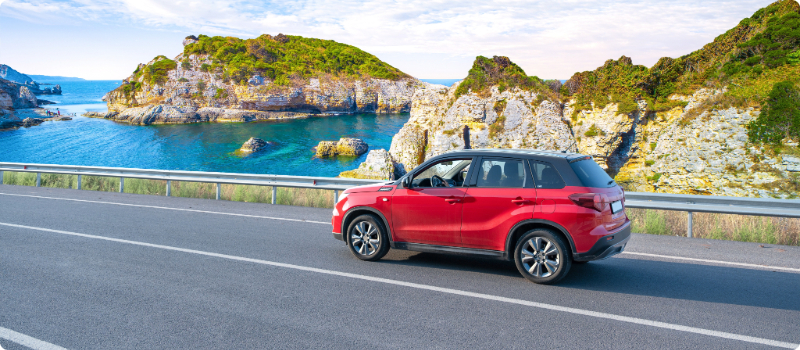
<box><xmin>392</xmin><ymin>157</ymin><xmax>472</xmax><ymax>246</ymax></box>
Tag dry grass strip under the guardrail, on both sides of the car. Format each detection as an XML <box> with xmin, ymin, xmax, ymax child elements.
<box><xmin>3</xmin><ymin>171</ymin><xmax>800</xmax><ymax>246</ymax></box>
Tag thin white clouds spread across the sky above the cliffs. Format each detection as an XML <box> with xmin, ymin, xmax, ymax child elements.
<box><xmin>0</xmin><ymin>0</ymin><xmax>770</xmax><ymax>79</ymax></box>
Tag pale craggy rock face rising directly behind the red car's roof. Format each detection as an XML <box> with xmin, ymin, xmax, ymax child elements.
<box><xmin>389</xmin><ymin>83</ymin><xmax>575</xmax><ymax>170</ymax></box>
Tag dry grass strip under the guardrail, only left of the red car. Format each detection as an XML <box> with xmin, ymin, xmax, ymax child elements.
<box><xmin>3</xmin><ymin>171</ymin><xmax>333</xmax><ymax>208</ymax></box>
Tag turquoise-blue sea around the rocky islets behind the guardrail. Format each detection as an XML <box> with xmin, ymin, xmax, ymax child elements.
<box><xmin>0</xmin><ymin>79</ymin><xmax>459</xmax><ymax>177</ymax></box>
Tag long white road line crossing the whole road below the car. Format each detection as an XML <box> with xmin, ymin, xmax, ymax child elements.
<box><xmin>0</xmin><ymin>222</ymin><xmax>800</xmax><ymax>349</ymax></box>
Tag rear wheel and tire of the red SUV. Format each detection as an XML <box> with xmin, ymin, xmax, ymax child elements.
<box><xmin>514</xmin><ymin>228</ymin><xmax>572</xmax><ymax>284</ymax></box>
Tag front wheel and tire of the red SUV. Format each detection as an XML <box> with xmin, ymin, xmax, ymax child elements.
<box><xmin>345</xmin><ymin>214</ymin><xmax>389</xmax><ymax>261</ymax></box>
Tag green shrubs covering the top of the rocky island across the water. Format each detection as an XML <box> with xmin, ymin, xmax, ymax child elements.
<box><xmin>184</xmin><ymin>34</ymin><xmax>408</xmax><ymax>85</ymax></box>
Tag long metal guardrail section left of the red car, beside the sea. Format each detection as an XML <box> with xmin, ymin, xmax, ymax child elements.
<box><xmin>0</xmin><ymin>162</ymin><xmax>381</xmax><ymax>204</ymax></box>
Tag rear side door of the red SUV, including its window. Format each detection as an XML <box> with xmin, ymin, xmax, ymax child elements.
<box><xmin>461</xmin><ymin>157</ymin><xmax>536</xmax><ymax>250</ymax></box>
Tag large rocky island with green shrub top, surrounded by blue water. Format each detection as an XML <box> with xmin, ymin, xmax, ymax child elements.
<box><xmin>104</xmin><ymin>34</ymin><xmax>420</xmax><ymax>124</ymax></box>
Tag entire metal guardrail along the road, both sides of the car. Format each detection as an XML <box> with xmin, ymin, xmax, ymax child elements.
<box><xmin>0</xmin><ymin>162</ymin><xmax>800</xmax><ymax>237</ymax></box>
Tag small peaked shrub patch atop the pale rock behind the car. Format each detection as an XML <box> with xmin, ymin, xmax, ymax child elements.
<box><xmin>455</xmin><ymin>56</ymin><xmax>550</xmax><ymax>98</ymax></box>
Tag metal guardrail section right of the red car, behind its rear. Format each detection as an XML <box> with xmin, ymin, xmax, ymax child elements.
<box><xmin>625</xmin><ymin>192</ymin><xmax>800</xmax><ymax>237</ymax></box>
